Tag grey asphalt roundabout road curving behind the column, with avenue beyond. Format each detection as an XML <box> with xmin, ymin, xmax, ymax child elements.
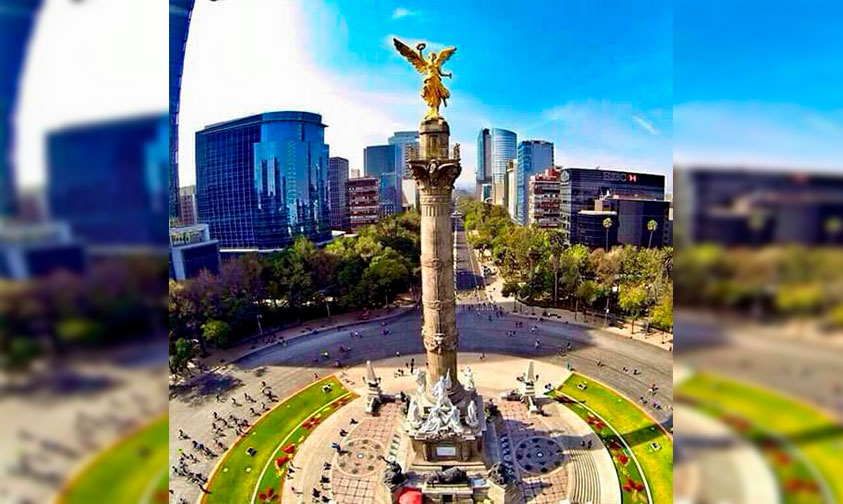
<box><xmin>170</xmin><ymin>219</ymin><xmax>673</xmax><ymax>502</ymax></box>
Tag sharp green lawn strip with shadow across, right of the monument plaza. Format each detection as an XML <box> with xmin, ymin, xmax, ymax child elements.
<box><xmin>555</xmin><ymin>373</ymin><xmax>673</xmax><ymax>504</ymax></box>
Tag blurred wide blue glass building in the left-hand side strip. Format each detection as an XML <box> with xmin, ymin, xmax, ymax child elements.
<box><xmin>47</xmin><ymin>114</ymin><xmax>169</xmax><ymax>247</ymax></box>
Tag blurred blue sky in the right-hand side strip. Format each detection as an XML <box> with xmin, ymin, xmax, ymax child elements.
<box><xmin>674</xmin><ymin>0</ymin><xmax>843</xmax><ymax>172</ymax></box>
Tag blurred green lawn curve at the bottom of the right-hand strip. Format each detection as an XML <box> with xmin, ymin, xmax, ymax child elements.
<box><xmin>676</xmin><ymin>373</ymin><xmax>843</xmax><ymax>503</ymax></box>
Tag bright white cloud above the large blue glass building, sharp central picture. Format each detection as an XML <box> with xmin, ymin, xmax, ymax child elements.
<box><xmin>179</xmin><ymin>0</ymin><xmax>411</xmax><ymax>185</ymax></box>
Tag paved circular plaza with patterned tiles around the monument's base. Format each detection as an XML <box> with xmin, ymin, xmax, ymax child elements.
<box><xmin>272</xmin><ymin>354</ymin><xmax>620</xmax><ymax>504</ymax></box>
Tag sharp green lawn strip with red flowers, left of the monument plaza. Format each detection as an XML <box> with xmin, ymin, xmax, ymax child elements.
<box><xmin>203</xmin><ymin>376</ymin><xmax>351</xmax><ymax>504</ymax></box>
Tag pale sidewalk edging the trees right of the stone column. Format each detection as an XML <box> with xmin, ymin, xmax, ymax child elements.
<box><xmin>475</xmin><ymin>252</ymin><xmax>673</xmax><ymax>351</ymax></box>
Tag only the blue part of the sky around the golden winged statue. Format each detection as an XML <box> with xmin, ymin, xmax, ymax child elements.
<box><xmin>304</xmin><ymin>1</ymin><xmax>673</xmax><ymax>187</ymax></box>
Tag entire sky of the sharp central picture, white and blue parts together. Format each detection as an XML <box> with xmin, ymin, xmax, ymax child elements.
<box><xmin>175</xmin><ymin>0</ymin><xmax>673</xmax><ymax>188</ymax></box>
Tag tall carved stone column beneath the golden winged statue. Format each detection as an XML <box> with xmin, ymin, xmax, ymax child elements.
<box><xmin>410</xmin><ymin>118</ymin><xmax>463</xmax><ymax>403</ymax></box>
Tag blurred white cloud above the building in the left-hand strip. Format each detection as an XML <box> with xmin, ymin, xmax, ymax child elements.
<box><xmin>15</xmin><ymin>0</ymin><xmax>169</xmax><ymax>187</ymax></box>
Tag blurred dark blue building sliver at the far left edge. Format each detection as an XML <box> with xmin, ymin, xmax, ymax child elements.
<box><xmin>0</xmin><ymin>0</ymin><xmax>41</xmax><ymax>219</ymax></box>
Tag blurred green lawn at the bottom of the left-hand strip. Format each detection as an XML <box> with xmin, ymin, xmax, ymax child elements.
<box><xmin>59</xmin><ymin>416</ymin><xmax>169</xmax><ymax>504</ymax></box>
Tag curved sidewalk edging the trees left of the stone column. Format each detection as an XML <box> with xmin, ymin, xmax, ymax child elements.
<box><xmin>171</xmin><ymin>300</ymin><xmax>416</xmax><ymax>384</ymax></box>
